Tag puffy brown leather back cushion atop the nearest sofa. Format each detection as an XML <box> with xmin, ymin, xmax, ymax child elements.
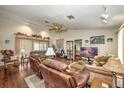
<box><xmin>43</xmin><ymin>59</ymin><xmax>68</xmax><ymax>72</ymax></box>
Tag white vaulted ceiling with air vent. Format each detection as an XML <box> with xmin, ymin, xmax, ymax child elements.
<box><xmin>0</xmin><ymin>5</ymin><xmax>124</xmax><ymax>29</ymax></box>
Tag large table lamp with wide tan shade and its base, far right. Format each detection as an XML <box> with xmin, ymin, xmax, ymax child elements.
<box><xmin>103</xmin><ymin>57</ymin><xmax>124</xmax><ymax>88</ymax></box>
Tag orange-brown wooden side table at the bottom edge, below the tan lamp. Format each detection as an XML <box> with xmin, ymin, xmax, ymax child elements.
<box><xmin>91</xmin><ymin>77</ymin><xmax>112</xmax><ymax>88</ymax></box>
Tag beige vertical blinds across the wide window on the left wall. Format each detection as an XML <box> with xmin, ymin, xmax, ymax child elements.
<box><xmin>15</xmin><ymin>38</ymin><xmax>48</xmax><ymax>55</ymax></box>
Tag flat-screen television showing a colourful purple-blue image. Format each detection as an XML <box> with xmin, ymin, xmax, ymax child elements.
<box><xmin>80</xmin><ymin>47</ymin><xmax>98</xmax><ymax>58</ymax></box>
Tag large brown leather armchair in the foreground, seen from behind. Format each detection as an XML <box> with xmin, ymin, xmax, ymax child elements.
<box><xmin>40</xmin><ymin>60</ymin><xmax>89</xmax><ymax>88</ymax></box>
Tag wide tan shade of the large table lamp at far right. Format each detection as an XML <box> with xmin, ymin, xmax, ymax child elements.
<box><xmin>103</xmin><ymin>58</ymin><xmax>124</xmax><ymax>74</ymax></box>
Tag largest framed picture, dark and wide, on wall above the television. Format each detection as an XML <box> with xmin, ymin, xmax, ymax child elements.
<box><xmin>90</xmin><ymin>35</ymin><xmax>105</xmax><ymax>44</ymax></box>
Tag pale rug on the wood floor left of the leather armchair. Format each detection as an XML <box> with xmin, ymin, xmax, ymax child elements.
<box><xmin>24</xmin><ymin>75</ymin><xmax>45</xmax><ymax>88</ymax></box>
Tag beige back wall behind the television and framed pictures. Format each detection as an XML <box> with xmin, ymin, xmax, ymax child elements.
<box><xmin>53</xmin><ymin>29</ymin><xmax>118</xmax><ymax>56</ymax></box>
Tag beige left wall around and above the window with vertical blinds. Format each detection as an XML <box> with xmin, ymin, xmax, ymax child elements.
<box><xmin>0</xmin><ymin>11</ymin><xmax>55</xmax><ymax>54</ymax></box>
